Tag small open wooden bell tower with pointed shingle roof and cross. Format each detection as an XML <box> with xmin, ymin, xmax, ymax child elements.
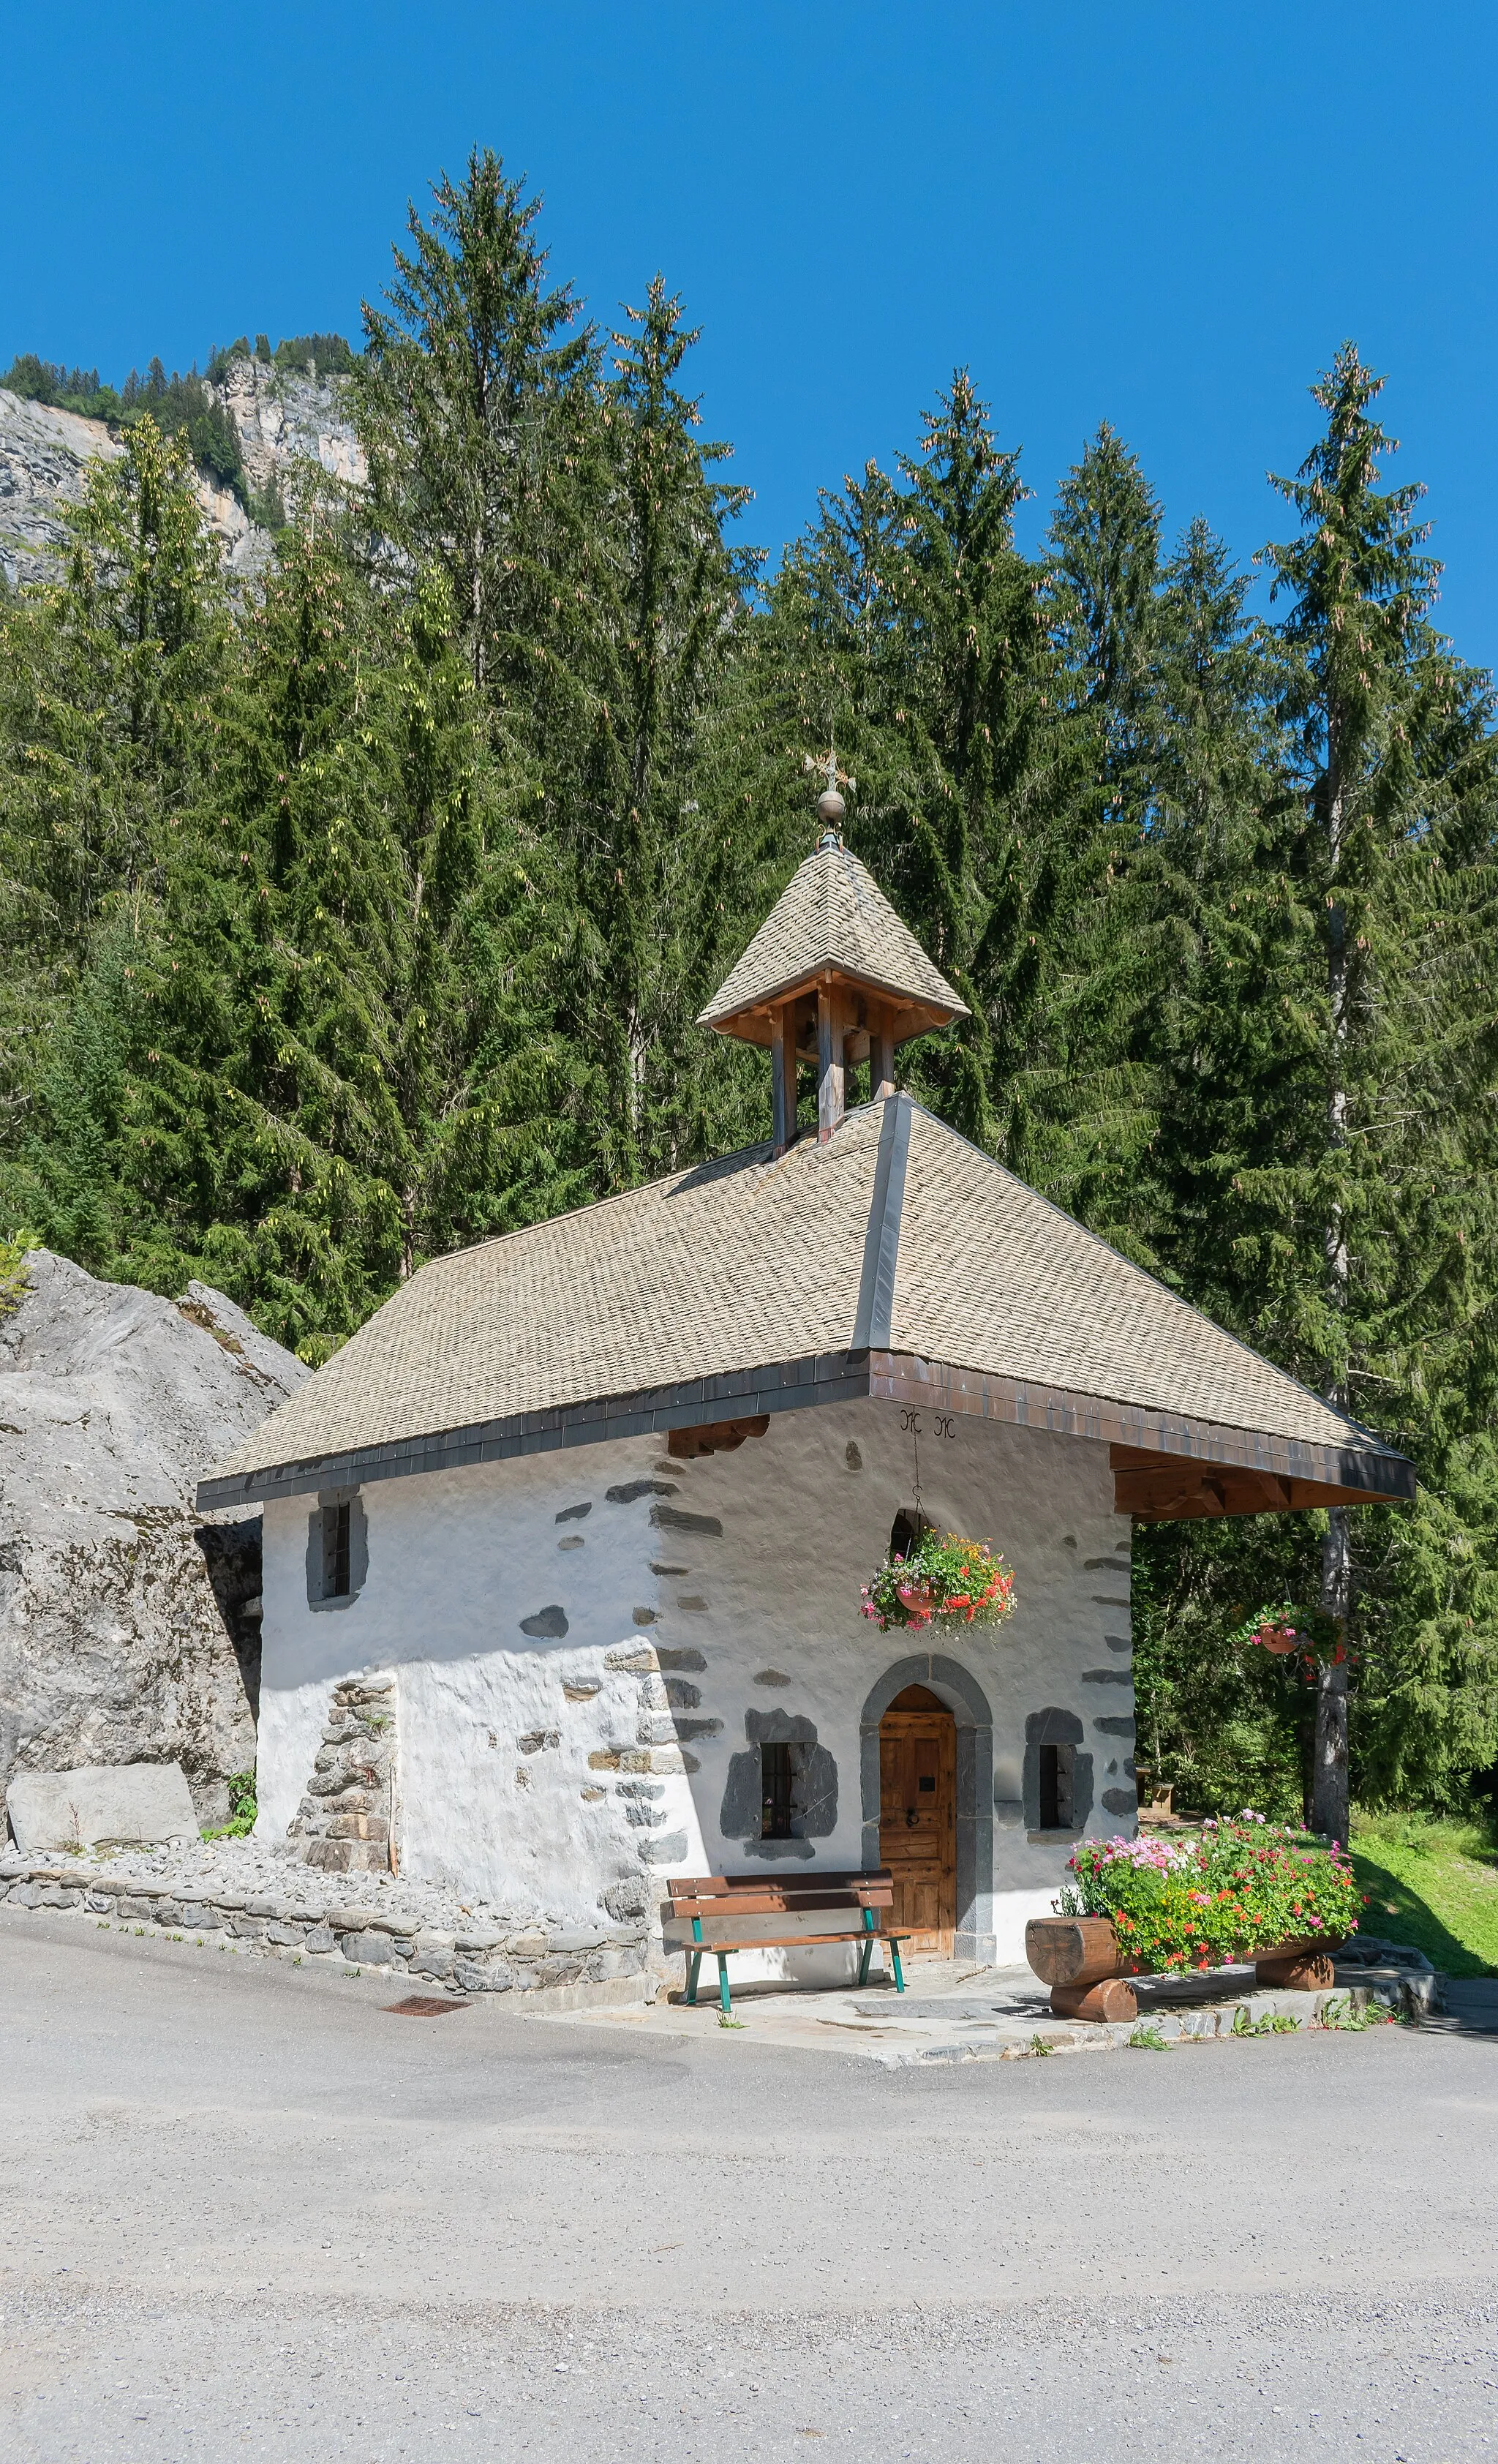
<box><xmin>697</xmin><ymin>762</ymin><xmax>968</xmax><ymax>1156</ymax></box>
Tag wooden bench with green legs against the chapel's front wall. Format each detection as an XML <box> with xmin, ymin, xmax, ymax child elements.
<box><xmin>665</xmin><ymin>1866</ymin><xmax>909</xmax><ymax>2013</ymax></box>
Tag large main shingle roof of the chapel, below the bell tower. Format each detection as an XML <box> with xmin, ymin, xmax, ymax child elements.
<box><xmin>200</xmin><ymin>1094</ymin><xmax>1414</xmax><ymax>1513</ymax></box>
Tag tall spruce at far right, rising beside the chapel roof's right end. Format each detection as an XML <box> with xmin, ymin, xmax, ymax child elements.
<box><xmin>1133</xmin><ymin>348</ymin><xmax>1498</xmax><ymax>1838</ymax></box>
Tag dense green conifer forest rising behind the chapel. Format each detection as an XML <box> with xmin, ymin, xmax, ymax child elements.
<box><xmin>0</xmin><ymin>153</ymin><xmax>1498</xmax><ymax>1814</ymax></box>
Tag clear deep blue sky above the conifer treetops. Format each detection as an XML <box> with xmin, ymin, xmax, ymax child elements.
<box><xmin>0</xmin><ymin>0</ymin><xmax>1498</xmax><ymax>663</ymax></box>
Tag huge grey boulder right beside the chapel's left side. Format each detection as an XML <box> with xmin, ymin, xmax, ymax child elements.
<box><xmin>0</xmin><ymin>1250</ymin><xmax>308</xmax><ymax>1838</ymax></box>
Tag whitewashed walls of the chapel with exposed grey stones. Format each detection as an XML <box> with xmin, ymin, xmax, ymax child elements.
<box><xmin>259</xmin><ymin>1402</ymin><xmax>1133</xmax><ymax>1959</ymax></box>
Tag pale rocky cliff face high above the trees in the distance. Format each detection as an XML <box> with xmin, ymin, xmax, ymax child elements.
<box><xmin>0</xmin><ymin>360</ymin><xmax>365</xmax><ymax>589</ymax></box>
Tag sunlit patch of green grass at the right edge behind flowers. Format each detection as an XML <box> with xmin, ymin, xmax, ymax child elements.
<box><xmin>1350</xmin><ymin>1811</ymin><xmax>1498</xmax><ymax>1976</ymax></box>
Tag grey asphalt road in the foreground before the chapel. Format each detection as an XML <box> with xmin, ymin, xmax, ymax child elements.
<box><xmin>0</xmin><ymin>1912</ymin><xmax>1498</xmax><ymax>2464</ymax></box>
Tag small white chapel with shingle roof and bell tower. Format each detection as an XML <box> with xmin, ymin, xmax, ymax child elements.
<box><xmin>197</xmin><ymin>818</ymin><xmax>1414</xmax><ymax>1976</ymax></box>
